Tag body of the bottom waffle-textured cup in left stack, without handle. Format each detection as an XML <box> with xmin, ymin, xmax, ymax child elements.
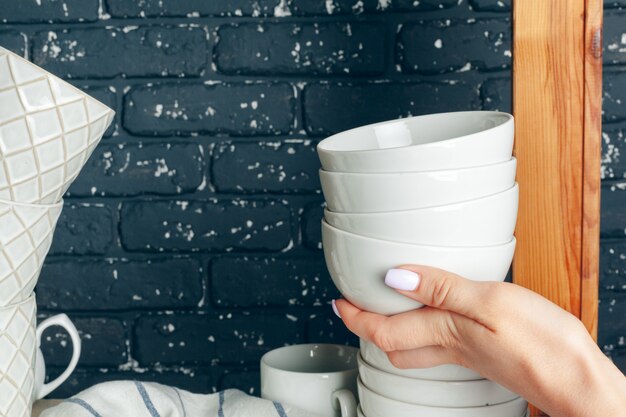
<box><xmin>0</xmin><ymin>294</ymin><xmax>37</xmax><ymax>417</ymax></box>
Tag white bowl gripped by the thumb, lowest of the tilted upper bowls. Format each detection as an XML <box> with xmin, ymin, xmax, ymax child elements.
<box><xmin>322</xmin><ymin>220</ymin><xmax>515</xmax><ymax>315</ymax></box>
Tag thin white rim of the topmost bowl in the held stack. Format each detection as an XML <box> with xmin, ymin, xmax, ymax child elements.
<box><xmin>317</xmin><ymin>110</ymin><xmax>515</xmax><ymax>154</ymax></box>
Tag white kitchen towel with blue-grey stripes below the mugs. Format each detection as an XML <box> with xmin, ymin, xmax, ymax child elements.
<box><xmin>41</xmin><ymin>381</ymin><xmax>317</xmax><ymax>417</ymax></box>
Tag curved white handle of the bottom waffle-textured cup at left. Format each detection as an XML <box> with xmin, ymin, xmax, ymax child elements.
<box><xmin>33</xmin><ymin>314</ymin><xmax>81</xmax><ymax>401</ymax></box>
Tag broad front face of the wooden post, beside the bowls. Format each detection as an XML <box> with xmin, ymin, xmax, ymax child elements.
<box><xmin>513</xmin><ymin>0</ymin><xmax>585</xmax><ymax>316</ymax></box>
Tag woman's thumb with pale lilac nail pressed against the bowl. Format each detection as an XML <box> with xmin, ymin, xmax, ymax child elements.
<box><xmin>385</xmin><ymin>265</ymin><xmax>497</xmax><ymax>322</ymax></box>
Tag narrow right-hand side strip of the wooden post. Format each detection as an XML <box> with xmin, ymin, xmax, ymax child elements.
<box><xmin>580</xmin><ymin>0</ymin><xmax>603</xmax><ymax>340</ymax></box>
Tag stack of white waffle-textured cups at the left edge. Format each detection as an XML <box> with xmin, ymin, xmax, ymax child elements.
<box><xmin>0</xmin><ymin>47</ymin><xmax>114</xmax><ymax>417</ymax></box>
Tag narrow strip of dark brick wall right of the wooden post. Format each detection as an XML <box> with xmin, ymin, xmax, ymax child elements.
<box><xmin>599</xmin><ymin>0</ymin><xmax>626</xmax><ymax>372</ymax></box>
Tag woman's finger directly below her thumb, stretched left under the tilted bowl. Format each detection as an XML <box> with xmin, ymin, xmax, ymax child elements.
<box><xmin>336</xmin><ymin>300</ymin><xmax>462</xmax><ymax>352</ymax></box>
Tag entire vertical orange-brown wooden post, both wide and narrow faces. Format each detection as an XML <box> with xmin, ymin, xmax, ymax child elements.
<box><xmin>513</xmin><ymin>0</ymin><xmax>602</xmax><ymax>415</ymax></box>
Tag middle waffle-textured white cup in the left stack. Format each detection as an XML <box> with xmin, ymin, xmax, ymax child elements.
<box><xmin>0</xmin><ymin>200</ymin><xmax>63</xmax><ymax>306</ymax></box>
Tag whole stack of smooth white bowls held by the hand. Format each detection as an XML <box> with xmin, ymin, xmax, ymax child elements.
<box><xmin>317</xmin><ymin>111</ymin><xmax>527</xmax><ymax>417</ymax></box>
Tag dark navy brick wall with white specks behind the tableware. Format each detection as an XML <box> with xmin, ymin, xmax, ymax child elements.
<box><xmin>0</xmin><ymin>0</ymin><xmax>626</xmax><ymax>397</ymax></box>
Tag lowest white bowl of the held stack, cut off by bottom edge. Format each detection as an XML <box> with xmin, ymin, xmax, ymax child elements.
<box><xmin>358</xmin><ymin>378</ymin><xmax>528</xmax><ymax>417</ymax></box>
